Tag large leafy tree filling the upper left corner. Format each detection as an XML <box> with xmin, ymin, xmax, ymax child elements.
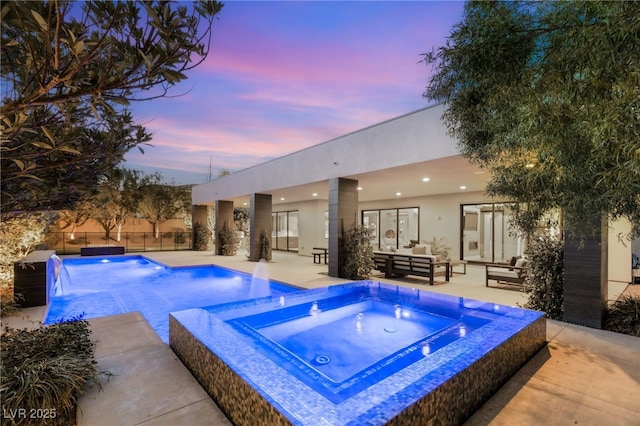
<box><xmin>0</xmin><ymin>0</ymin><xmax>222</xmax><ymax>213</ymax></box>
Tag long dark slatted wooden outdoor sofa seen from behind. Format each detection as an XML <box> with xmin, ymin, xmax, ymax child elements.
<box><xmin>373</xmin><ymin>253</ymin><xmax>450</xmax><ymax>285</ymax></box>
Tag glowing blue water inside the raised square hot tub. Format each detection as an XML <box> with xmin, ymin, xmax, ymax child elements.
<box><xmin>222</xmin><ymin>284</ymin><xmax>502</xmax><ymax>403</ymax></box>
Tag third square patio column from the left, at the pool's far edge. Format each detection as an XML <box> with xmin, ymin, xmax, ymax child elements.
<box><xmin>249</xmin><ymin>194</ymin><xmax>273</xmax><ymax>262</ymax></box>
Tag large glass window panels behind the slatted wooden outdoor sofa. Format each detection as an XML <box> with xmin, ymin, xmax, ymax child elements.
<box><xmin>362</xmin><ymin>207</ymin><xmax>420</xmax><ymax>248</ymax></box>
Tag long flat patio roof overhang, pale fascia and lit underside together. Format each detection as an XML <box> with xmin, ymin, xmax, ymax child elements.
<box><xmin>193</xmin><ymin>105</ymin><xmax>488</xmax><ymax>207</ymax></box>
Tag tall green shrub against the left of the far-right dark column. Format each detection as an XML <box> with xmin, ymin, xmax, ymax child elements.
<box><xmin>524</xmin><ymin>237</ymin><xmax>564</xmax><ymax>320</ymax></box>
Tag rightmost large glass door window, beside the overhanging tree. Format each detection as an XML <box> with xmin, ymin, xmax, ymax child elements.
<box><xmin>460</xmin><ymin>203</ymin><xmax>524</xmax><ymax>263</ymax></box>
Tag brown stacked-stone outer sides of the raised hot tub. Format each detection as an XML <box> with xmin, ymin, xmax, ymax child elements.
<box><xmin>169</xmin><ymin>316</ymin><xmax>546</xmax><ymax>426</ymax></box>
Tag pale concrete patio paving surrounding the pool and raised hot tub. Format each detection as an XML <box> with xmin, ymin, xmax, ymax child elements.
<box><xmin>3</xmin><ymin>252</ymin><xmax>640</xmax><ymax>426</ymax></box>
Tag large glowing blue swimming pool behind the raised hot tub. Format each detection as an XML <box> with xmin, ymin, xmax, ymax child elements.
<box><xmin>44</xmin><ymin>256</ymin><xmax>299</xmax><ymax>342</ymax></box>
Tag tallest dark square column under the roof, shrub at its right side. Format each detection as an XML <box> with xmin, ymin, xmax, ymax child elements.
<box><xmin>329</xmin><ymin>178</ymin><xmax>358</xmax><ymax>278</ymax></box>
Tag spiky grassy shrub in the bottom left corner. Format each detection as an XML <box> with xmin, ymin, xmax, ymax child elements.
<box><xmin>0</xmin><ymin>318</ymin><xmax>100</xmax><ymax>425</ymax></box>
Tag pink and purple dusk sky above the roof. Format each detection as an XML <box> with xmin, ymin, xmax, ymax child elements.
<box><xmin>125</xmin><ymin>1</ymin><xmax>464</xmax><ymax>184</ymax></box>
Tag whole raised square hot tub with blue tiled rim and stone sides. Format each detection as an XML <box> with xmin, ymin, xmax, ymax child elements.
<box><xmin>169</xmin><ymin>281</ymin><xmax>545</xmax><ymax>426</ymax></box>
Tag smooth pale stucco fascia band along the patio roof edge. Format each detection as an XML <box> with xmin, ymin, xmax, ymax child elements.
<box><xmin>192</xmin><ymin>105</ymin><xmax>459</xmax><ymax>204</ymax></box>
